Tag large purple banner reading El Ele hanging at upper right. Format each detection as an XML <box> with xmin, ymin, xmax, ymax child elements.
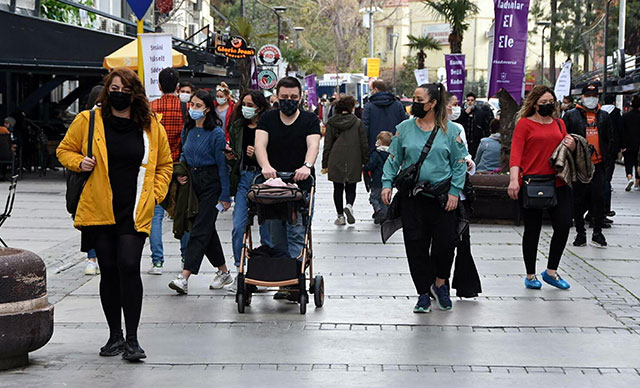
<box><xmin>488</xmin><ymin>0</ymin><xmax>529</xmax><ymax>104</ymax></box>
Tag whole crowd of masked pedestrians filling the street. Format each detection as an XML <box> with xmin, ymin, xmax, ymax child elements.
<box><xmin>57</xmin><ymin>68</ymin><xmax>640</xmax><ymax>360</ymax></box>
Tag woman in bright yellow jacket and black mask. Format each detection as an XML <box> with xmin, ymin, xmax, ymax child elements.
<box><xmin>57</xmin><ymin>68</ymin><xmax>173</xmax><ymax>361</ymax></box>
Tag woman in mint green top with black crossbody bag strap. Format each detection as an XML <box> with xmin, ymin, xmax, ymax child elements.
<box><xmin>382</xmin><ymin>84</ymin><xmax>467</xmax><ymax>313</ymax></box>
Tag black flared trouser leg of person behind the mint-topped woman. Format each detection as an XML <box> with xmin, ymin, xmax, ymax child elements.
<box><xmin>451</xmin><ymin>201</ymin><xmax>482</xmax><ymax>298</ymax></box>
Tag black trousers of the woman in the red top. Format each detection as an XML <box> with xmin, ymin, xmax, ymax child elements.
<box><xmin>521</xmin><ymin>186</ymin><xmax>572</xmax><ymax>275</ymax></box>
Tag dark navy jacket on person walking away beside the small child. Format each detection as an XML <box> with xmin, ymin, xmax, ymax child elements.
<box><xmin>362</xmin><ymin>92</ymin><xmax>407</xmax><ymax>152</ymax></box>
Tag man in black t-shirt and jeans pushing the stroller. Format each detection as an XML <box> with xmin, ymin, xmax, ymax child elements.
<box><xmin>255</xmin><ymin>77</ymin><xmax>320</xmax><ymax>268</ymax></box>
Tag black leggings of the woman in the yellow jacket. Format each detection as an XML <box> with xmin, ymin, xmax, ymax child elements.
<box><xmin>95</xmin><ymin>230</ymin><xmax>147</xmax><ymax>337</ymax></box>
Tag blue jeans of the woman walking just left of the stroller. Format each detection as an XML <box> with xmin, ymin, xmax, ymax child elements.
<box><xmin>231</xmin><ymin>171</ymin><xmax>271</xmax><ymax>267</ymax></box>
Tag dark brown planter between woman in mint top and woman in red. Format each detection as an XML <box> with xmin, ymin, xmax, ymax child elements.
<box><xmin>471</xmin><ymin>174</ymin><xmax>520</xmax><ymax>224</ymax></box>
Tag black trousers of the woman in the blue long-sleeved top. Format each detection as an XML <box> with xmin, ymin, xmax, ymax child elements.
<box><xmin>184</xmin><ymin>166</ymin><xmax>224</xmax><ymax>275</ymax></box>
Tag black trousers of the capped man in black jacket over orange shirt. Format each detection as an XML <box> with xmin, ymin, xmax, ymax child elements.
<box><xmin>573</xmin><ymin>163</ymin><xmax>606</xmax><ymax>234</ymax></box>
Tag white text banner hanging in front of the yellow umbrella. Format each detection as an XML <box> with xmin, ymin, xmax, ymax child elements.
<box><xmin>140</xmin><ymin>34</ymin><xmax>173</xmax><ymax>101</ymax></box>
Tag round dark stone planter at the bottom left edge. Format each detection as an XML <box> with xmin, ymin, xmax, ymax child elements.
<box><xmin>0</xmin><ymin>248</ymin><xmax>53</xmax><ymax>370</ymax></box>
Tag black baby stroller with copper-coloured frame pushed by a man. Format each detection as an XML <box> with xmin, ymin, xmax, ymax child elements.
<box><xmin>236</xmin><ymin>173</ymin><xmax>324</xmax><ymax>314</ymax></box>
